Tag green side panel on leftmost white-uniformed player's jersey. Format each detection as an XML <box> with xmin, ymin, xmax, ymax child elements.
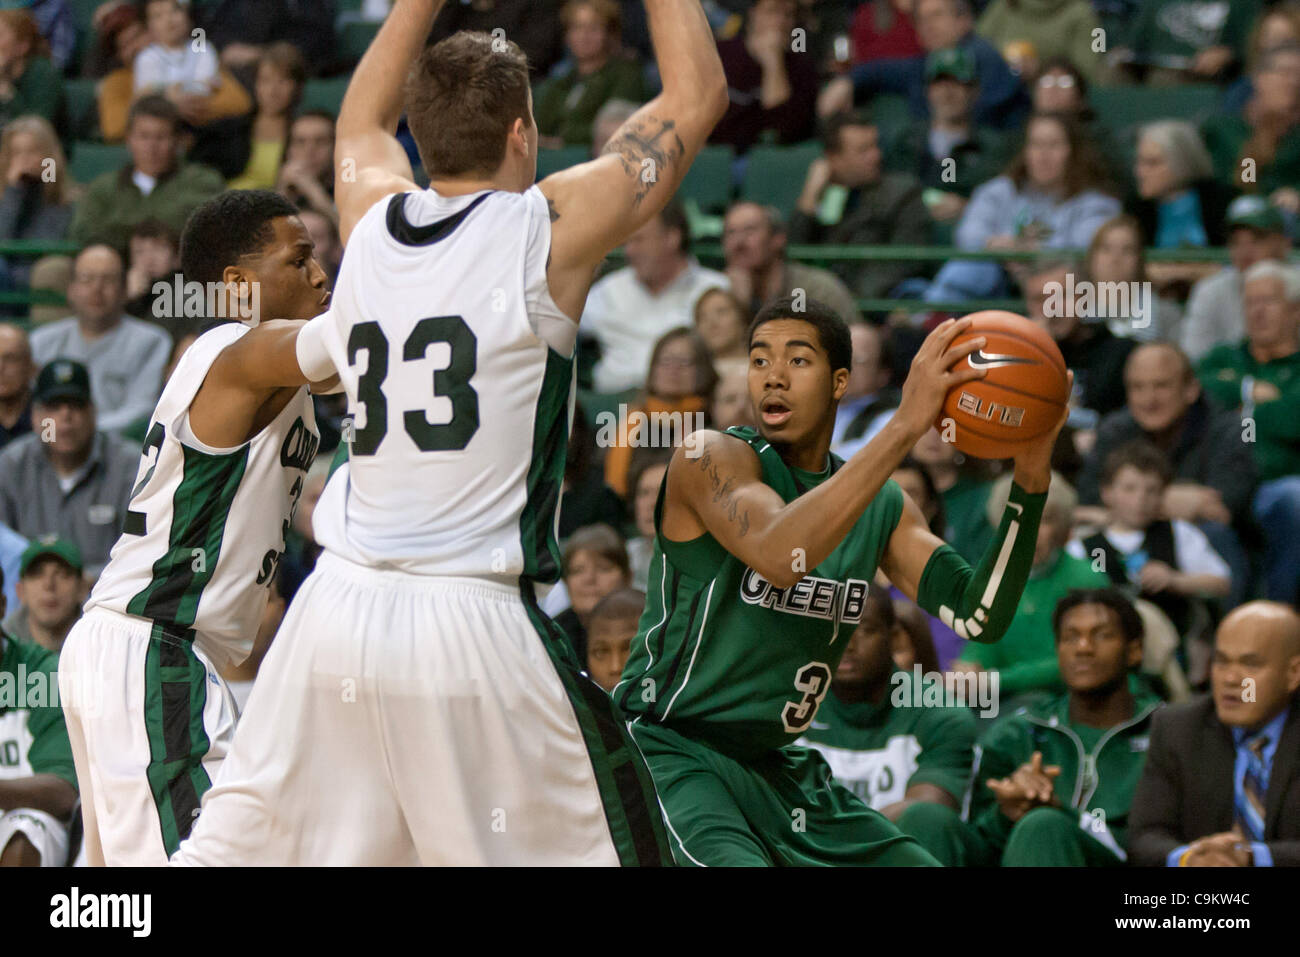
<box><xmin>126</xmin><ymin>445</ymin><xmax>250</xmax><ymax>628</ymax></box>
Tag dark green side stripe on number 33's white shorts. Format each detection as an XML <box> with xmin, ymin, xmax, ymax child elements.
<box><xmin>521</xmin><ymin>579</ymin><xmax>673</xmax><ymax>867</ymax></box>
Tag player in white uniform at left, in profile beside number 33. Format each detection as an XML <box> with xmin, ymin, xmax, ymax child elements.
<box><xmin>59</xmin><ymin>191</ymin><xmax>329</xmax><ymax>865</ymax></box>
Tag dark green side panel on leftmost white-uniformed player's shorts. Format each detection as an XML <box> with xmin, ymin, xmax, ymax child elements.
<box><xmin>144</xmin><ymin>623</ymin><xmax>212</xmax><ymax>857</ymax></box>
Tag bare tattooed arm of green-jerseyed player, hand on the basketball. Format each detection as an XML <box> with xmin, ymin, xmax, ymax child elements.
<box><xmin>663</xmin><ymin>319</ymin><xmax>984</xmax><ymax>588</ymax></box>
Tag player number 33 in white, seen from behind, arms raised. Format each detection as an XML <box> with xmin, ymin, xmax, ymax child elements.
<box><xmin>173</xmin><ymin>0</ymin><xmax>727</xmax><ymax>865</ymax></box>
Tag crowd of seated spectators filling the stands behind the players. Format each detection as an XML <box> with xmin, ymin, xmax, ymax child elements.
<box><xmin>0</xmin><ymin>0</ymin><xmax>1300</xmax><ymax>866</ymax></box>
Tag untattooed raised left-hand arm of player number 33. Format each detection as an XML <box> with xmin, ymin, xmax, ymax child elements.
<box><xmin>334</xmin><ymin>0</ymin><xmax>443</xmax><ymax>246</ymax></box>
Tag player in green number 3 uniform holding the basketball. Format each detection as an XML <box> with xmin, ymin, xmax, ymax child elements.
<box><xmin>614</xmin><ymin>298</ymin><xmax>1065</xmax><ymax>866</ymax></box>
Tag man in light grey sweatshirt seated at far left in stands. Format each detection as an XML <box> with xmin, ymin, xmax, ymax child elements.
<box><xmin>31</xmin><ymin>246</ymin><xmax>172</xmax><ymax>432</ymax></box>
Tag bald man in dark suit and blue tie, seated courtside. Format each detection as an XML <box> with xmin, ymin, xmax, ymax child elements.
<box><xmin>1128</xmin><ymin>602</ymin><xmax>1300</xmax><ymax>867</ymax></box>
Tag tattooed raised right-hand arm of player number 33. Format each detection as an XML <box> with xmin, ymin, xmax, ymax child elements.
<box><xmin>541</xmin><ymin>0</ymin><xmax>728</xmax><ymax>317</ymax></box>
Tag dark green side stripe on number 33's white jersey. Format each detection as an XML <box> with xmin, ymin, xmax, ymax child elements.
<box><xmin>519</xmin><ymin>348</ymin><xmax>573</xmax><ymax>583</ymax></box>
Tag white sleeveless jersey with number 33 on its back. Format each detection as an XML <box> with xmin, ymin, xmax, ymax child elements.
<box><xmin>298</xmin><ymin>186</ymin><xmax>577</xmax><ymax>581</ymax></box>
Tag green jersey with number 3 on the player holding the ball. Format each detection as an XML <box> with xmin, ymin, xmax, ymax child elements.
<box><xmin>614</xmin><ymin>428</ymin><xmax>904</xmax><ymax>758</ymax></box>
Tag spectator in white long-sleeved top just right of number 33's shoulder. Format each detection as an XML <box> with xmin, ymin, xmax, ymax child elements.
<box><xmin>581</xmin><ymin>203</ymin><xmax>731</xmax><ymax>393</ymax></box>
